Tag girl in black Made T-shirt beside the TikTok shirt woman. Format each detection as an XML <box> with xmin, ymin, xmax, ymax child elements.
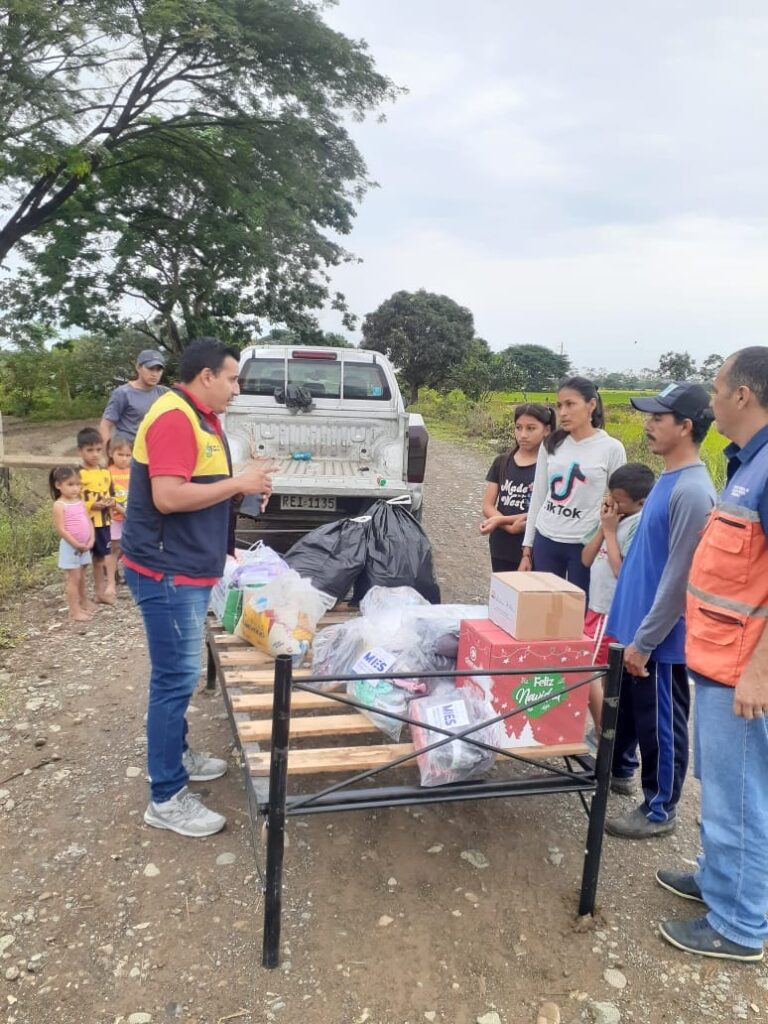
<box><xmin>480</xmin><ymin>402</ymin><xmax>557</xmax><ymax>572</ymax></box>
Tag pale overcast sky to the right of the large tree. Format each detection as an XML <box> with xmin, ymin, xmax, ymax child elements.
<box><xmin>325</xmin><ymin>0</ymin><xmax>768</xmax><ymax>369</ymax></box>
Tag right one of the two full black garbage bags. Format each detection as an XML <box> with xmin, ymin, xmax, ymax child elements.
<box><xmin>354</xmin><ymin>498</ymin><xmax>440</xmax><ymax>604</ymax></box>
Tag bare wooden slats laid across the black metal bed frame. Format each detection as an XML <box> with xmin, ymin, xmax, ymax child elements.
<box><xmin>208</xmin><ymin>606</ymin><xmax>588</xmax><ymax>792</ymax></box>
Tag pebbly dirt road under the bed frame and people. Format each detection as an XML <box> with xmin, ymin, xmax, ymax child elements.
<box><xmin>0</xmin><ymin>428</ymin><xmax>768</xmax><ymax>1024</ymax></box>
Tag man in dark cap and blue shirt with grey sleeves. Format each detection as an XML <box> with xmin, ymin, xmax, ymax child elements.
<box><xmin>605</xmin><ymin>384</ymin><xmax>716</xmax><ymax>839</ymax></box>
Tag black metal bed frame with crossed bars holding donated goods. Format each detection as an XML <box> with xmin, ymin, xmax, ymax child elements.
<box><xmin>206</xmin><ymin>629</ymin><xmax>624</xmax><ymax>968</ymax></box>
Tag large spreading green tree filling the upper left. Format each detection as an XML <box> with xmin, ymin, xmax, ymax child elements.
<box><xmin>0</xmin><ymin>0</ymin><xmax>395</xmax><ymax>350</ymax></box>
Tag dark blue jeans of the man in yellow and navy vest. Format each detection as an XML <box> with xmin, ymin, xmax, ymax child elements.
<box><xmin>125</xmin><ymin>568</ymin><xmax>211</xmax><ymax>804</ymax></box>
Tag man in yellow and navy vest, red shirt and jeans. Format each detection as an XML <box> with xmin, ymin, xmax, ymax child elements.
<box><xmin>122</xmin><ymin>338</ymin><xmax>271</xmax><ymax>838</ymax></box>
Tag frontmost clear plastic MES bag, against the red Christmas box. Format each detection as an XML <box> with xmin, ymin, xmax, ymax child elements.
<box><xmin>409</xmin><ymin>687</ymin><xmax>496</xmax><ymax>786</ymax></box>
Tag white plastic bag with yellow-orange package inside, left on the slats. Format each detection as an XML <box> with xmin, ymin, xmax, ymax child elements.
<box><xmin>234</xmin><ymin>569</ymin><xmax>333</xmax><ymax>666</ymax></box>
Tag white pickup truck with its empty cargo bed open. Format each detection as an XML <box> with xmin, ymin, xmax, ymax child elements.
<box><xmin>224</xmin><ymin>345</ymin><xmax>428</xmax><ymax>551</ymax></box>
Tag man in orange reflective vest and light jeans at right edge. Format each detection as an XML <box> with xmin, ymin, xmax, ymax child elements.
<box><xmin>656</xmin><ymin>346</ymin><xmax>768</xmax><ymax>961</ymax></box>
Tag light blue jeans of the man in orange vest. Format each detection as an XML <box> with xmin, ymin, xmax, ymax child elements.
<box><xmin>691</xmin><ymin>673</ymin><xmax>768</xmax><ymax>949</ymax></box>
